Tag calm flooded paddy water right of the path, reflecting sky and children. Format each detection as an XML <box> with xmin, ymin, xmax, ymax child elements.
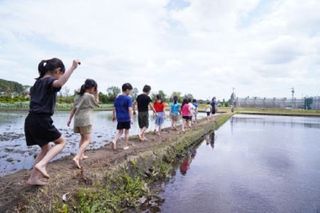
<box><xmin>161</xmin><ymin>115</ymin><xmax>320</xmax><ymax>213</ymax></box>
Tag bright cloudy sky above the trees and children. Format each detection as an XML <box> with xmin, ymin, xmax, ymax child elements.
<box><xmin>0</xmin><ymin>0</ymin><xmax>320</xmax><ymax>98</ymax></box>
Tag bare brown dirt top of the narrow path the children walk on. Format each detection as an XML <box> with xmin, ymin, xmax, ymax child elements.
<box><xmin>0</xmin><ymin>113</ymin><xmax>232</xmax><ymax>212</ymax></box>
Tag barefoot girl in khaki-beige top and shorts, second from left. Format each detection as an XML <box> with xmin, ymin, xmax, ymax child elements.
<box><xmin>68</xmin><ymin>79</ymin><xmax>99</xmax><ymax>169</ymax></box>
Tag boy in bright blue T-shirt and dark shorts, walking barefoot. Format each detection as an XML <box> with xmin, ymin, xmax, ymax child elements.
<box><xmin>112</xmin><ymin>83</ymin><xmax>132</xmax><ymax>150</ymax></box>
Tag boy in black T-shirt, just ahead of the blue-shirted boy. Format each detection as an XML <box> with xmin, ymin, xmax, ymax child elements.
<box><xmin>134</xmin><ymin>85</ymin><xmax>155</xmax><ymax>141</ymax></box>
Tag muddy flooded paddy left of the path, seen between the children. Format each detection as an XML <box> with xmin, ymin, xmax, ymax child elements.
<box><xmin>0</xmin><ymin>111</ymin><xmax>205</xmax><ymax>176</ymax></box>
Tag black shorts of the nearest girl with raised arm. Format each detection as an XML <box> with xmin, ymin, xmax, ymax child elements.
<box><xmin>24</xmin><ymin>113</ymin><xmax>61</xmax><ymax>147</ymax></box>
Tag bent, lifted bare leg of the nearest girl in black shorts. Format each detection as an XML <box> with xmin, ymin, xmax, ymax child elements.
<box><xmin>34</xmin><ymin>136</ymin><xmax>65</xmax><ymax>178</ymax></box>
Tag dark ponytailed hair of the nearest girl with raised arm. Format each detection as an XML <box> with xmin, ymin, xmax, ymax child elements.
<box><xmin>36</xmin><ymin>58</ymin><xmax>66</xmax><ymax>80</ymax></box>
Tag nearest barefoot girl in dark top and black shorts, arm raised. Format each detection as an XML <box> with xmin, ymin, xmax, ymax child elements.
<box><xmin>24</xmin><ymin>58</ymin><xmax>80</xmax><ymax>186</ymax></box>
